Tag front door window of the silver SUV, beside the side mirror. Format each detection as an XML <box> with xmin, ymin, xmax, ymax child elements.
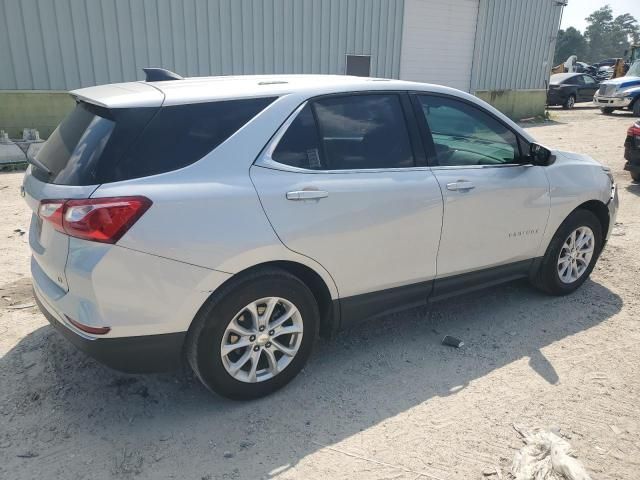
<box><xmin>418</xmin><ymin>95</ymin><xmax>521</xmax><ymax>167</ymax></box>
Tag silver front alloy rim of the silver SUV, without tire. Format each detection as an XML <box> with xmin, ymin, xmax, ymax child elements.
<box><xmin>557</xmin><ymin>227</ymin><xmax>595</xmax><ymax>284</ymax></box>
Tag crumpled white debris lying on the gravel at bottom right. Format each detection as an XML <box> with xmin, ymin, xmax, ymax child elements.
<box><xmin>511</xmin><ymin>424</ymin><xmax>591</xmax><ymax>480</ymax></box>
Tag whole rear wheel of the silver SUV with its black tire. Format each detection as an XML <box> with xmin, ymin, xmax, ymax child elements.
<box><xmin>186</xmin><ymin>268</ymin><xmax>320</xmax><ymax>400</ymax></box>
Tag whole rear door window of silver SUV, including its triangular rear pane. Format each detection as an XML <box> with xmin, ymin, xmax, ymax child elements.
<box><xmin>271</xmin><ymin>94</ymin><xmax>415</xmax><ymax>170</ymax></box>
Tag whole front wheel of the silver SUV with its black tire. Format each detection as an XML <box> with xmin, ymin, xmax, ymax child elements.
<box><xmin>532</xmin><ymin>209</ymin><xmax>603</xmax><ymax>295</ymax></box>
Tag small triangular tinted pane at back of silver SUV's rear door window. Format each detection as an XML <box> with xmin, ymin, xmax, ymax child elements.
<box><xmin>271</xmin><ymin>104</ymin><xmax>323</xmax><ymax>170</ymax></box>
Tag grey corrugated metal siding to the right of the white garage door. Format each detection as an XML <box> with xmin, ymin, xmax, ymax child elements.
<box><xmin>471</xmin><ymin>0</ymin><xmax>562</xmax><ymax>91</ymax></box>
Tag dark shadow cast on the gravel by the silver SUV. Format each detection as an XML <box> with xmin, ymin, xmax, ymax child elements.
<box><xmin>0</xmin><ymin>281</ymin><xmax>622</xmax><ymax>478</ymax></box>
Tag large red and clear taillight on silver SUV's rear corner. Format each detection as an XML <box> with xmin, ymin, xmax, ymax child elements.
<box><xmin>38</xmin><ymin>197</ymin><xmax>152</xmax><ymax>243</ymax></box>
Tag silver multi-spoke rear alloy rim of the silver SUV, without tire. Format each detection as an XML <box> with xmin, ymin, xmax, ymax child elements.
<box><xmin>220</xmin><ymin>297</ymin><xmax>304</xmax><ymax>383</ymax></box>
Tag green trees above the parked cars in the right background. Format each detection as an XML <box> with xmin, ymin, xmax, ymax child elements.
<box><xmin>554</xmin><ymin>5</ymin><xmax>640</xmax><ymax>65</ymax></box>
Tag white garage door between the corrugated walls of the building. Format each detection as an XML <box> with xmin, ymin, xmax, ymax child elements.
<box><xmin>400</xmin><ymin>0</ymin><xmax>479</xmax><ymax>91</ymax></box>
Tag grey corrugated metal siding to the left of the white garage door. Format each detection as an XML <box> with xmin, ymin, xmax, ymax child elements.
<box><xmin>0</xmin><ymin>0</ymin><xmax>404</xmax><ymax>90</ymax></box>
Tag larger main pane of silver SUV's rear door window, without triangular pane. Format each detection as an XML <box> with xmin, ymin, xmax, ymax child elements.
<box><xmin>314</xmin><ymin>95</ymin><xmax>414</xmax><ymax>170</ymax></box>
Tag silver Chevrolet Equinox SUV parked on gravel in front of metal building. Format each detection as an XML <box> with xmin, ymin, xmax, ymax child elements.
<box><xmin>23</xmin><ymin>72</ymin><xmax>617</xmax><ymax>399</ymax></box>
